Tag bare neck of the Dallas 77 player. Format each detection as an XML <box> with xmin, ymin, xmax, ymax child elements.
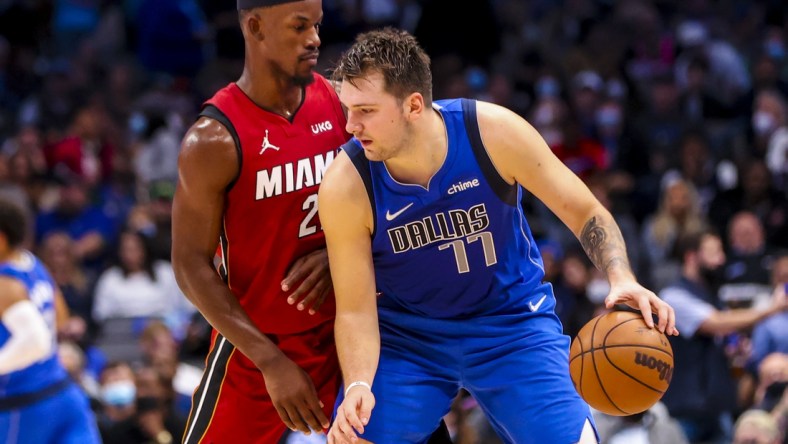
<box><xmin>385</xmin><ymin>111</ymin><xmax>448</xmax><ymax>188</ymax></box>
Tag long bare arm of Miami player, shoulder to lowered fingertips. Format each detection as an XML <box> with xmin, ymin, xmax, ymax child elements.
<box><xmin>172</xmin><ymin>118</ymin><xmax>328</xmax><ymax>433</ymax></box>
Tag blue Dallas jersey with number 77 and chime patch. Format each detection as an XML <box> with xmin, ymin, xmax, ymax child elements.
<box><xmin>343</xmin><ymin>99</ymin><xmax>552</xmax><ymax>318</ymax></box>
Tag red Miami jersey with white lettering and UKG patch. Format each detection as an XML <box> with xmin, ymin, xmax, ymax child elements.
<box><xmin>202</xmin><ymin>74</ymin><xmax>348</xmax><ymax>334</ymax></box>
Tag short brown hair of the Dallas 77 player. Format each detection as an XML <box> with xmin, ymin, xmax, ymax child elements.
<box><xmin>332</xmin><ymin>27</ymin><xmax>432</xmax><ymax>105</ymax></box>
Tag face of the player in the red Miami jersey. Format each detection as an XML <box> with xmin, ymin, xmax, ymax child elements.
<box><xmin>260</xmin><ymin>0</ymin><xmax>323</xmax><ymax>85</ymax></box>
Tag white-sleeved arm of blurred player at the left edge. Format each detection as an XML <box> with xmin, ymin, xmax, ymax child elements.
<box><xmin>0</xmin><ymin>276</ymin><xmax>53</xmax><ymax>375</ymax></box>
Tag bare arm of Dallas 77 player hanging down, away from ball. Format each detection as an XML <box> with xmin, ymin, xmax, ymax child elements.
<box><xmin>317</xmin><ymin>152</ymin><xmax>380</xmax><ymax>443</ymax></box>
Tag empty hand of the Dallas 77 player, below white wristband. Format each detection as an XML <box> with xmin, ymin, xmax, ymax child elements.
<box><xmin>328</xmin><ymin>387</ymin><xmax>375</xmax><ymax>444</ymax></box>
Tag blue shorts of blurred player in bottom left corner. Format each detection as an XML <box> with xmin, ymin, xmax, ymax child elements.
<box><xmin>0</xmin><ymin>384</ymin><xmax>101</xmax><ymax>444</ymax></box>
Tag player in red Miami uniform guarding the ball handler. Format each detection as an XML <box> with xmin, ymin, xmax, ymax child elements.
<box><xmin>172</xmin><ymin>0</ymin><xmax>456</xmax><ymax>444</ymax></box>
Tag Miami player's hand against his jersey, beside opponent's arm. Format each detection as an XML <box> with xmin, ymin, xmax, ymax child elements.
<box><xmin>281</xmin><ymin>248</ymin><xmax>332</xmax><ymax>314</ymax></box>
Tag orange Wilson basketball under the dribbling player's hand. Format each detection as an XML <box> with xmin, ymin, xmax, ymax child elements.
<box><xmin>569</xmin><ymin>311</ymin><xmax>673</xmax><ymax>416</ymax></box>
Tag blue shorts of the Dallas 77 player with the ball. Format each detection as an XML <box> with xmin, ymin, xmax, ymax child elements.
<box><xmin>337</xmin><ymin>295</ymin><xmax>593</xmax><ymax>444</ymax></box>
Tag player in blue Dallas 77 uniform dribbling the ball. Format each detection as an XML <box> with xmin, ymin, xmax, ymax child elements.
<box><xmin>319</xmin><ymin>28</ymin><xmax>677</xmax><ymax>444</ymax></box>
